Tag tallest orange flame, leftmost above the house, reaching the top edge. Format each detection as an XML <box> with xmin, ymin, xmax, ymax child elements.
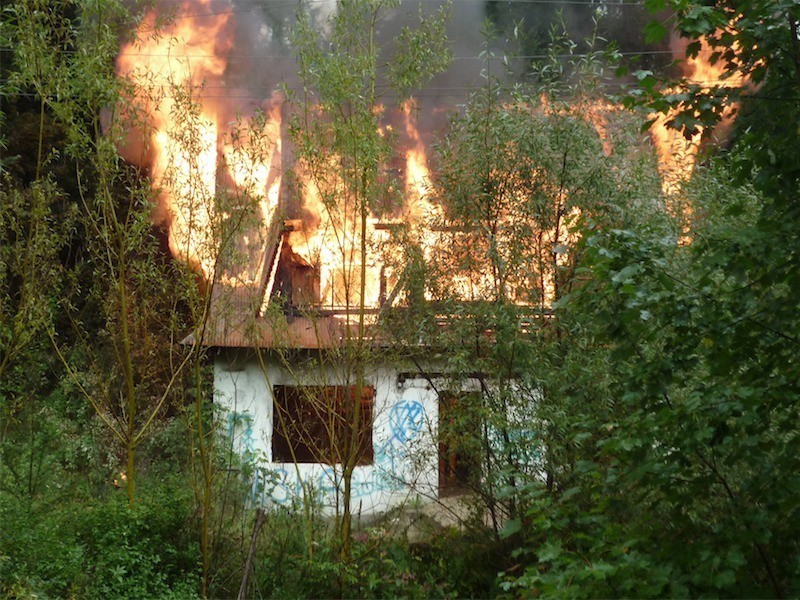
<box><xmin>117</xmin><ymin>0</ymin><xmax>232</xmax><ymax>278</ymax></box>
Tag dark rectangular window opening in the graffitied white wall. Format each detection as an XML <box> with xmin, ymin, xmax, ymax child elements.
<box><xmin>272</xmin><ymin>385</ymin><xmax>375</xmax><ymax>465</ymax></box>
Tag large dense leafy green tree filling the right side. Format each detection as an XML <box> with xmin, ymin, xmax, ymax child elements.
<box><xmin>500</xmin><ymin>2</ymin><xmax>798</xmax><ymax>597</ymax></box>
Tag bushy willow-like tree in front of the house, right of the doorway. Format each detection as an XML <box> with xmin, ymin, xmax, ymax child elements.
<box><xmin>396</xmin><ymin>21</ymin><xmax>659</xmax><ymax>538</ymax></box>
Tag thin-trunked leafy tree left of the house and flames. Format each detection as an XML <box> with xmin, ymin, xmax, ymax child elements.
<box><xmin>12</xmin><ymin>2</ymin><xmax>180</xmax><ymax>504</ymax></box>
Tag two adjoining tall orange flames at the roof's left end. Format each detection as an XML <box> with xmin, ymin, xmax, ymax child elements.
<box><xmin>117</xmin><ymin>0</ymin><xmax>280</xmax><ymax>280</ymax></box>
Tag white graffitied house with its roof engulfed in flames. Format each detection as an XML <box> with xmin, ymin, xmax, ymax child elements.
<box><xmin>117</xmin><ymin>0</ymin><xmax>740</xmax><ymax>513</ymax></box>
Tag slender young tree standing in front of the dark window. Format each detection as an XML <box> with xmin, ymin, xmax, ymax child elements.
<box><xmin>272</xmin><ymin>0</ymin><xmax>449</xmax><ymax>559</ymax></box>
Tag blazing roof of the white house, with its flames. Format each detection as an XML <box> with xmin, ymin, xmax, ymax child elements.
<box><xmin>112</xmin><ymin>0</ymin><xmax>744</xmax><ymax>348</ymax></box>
